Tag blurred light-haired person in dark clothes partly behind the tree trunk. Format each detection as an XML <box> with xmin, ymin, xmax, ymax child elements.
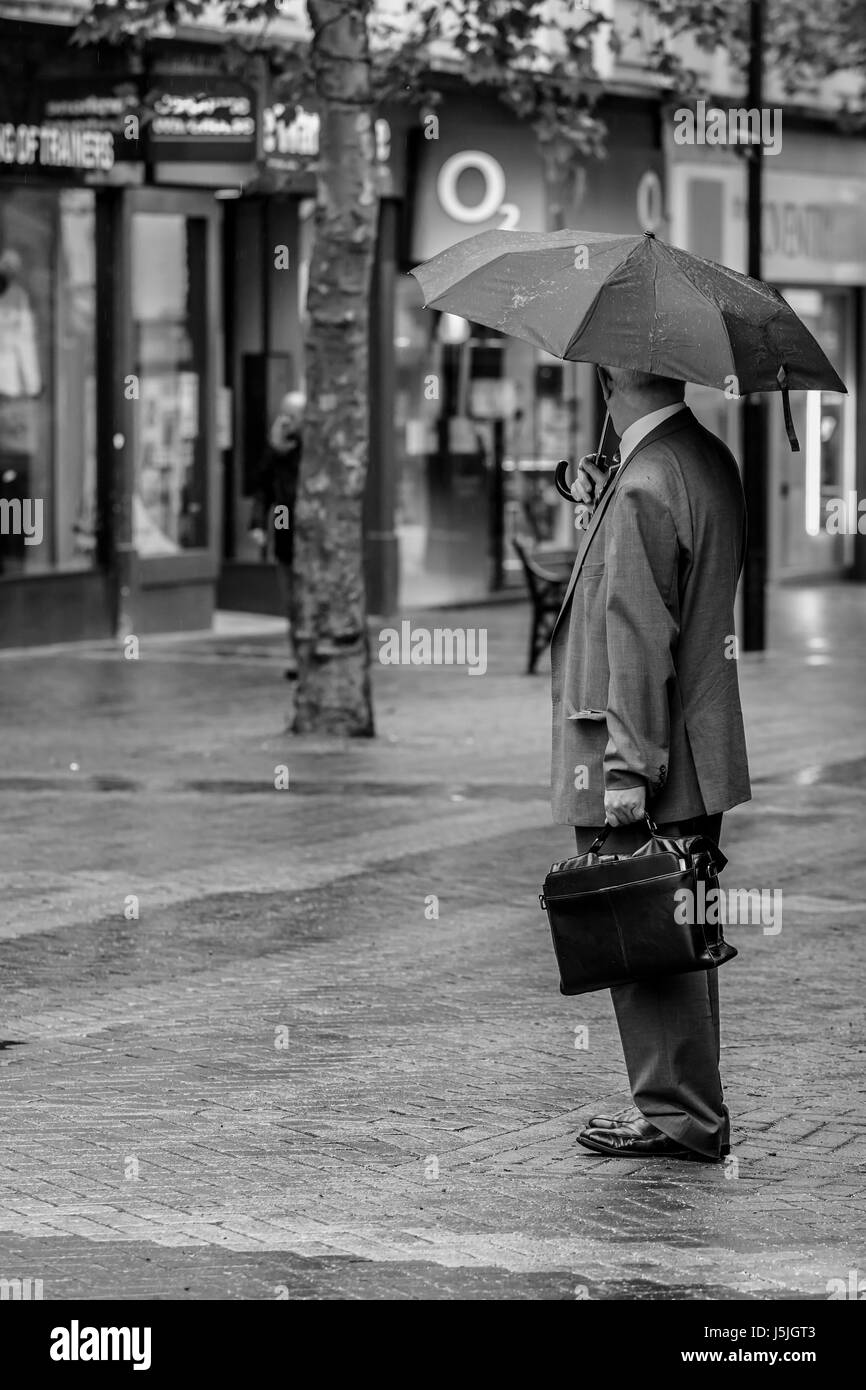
<box><xmin>250</xmin><ymin>391</ymin><xmax>306</xmax><ymax>680</ymax></box>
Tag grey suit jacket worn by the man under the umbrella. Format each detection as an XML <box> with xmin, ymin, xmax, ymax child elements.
<box><xmin>550</xmin><ymin>410</ymin><xmax>751</xmax><ymax>826</ymax></box>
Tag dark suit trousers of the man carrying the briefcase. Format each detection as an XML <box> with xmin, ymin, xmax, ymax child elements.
<box><xmin>574</xmin><ymin>815</ymin><xmax>730</xmax><ymax>1158</ymax></box>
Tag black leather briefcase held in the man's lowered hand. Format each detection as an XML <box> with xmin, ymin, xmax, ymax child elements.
<box><xmin>538</xmin><ymin>816</ymin><xmax>737</xmax><ymax>994</ymax></box>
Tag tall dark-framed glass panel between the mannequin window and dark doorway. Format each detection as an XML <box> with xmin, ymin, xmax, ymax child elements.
<box><xmin>124</xmin><ymin>188</ymin><xmax>222</xmax><ymax>631</ymax></box>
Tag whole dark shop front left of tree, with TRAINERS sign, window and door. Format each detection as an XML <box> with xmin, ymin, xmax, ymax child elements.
<box><xmin>0</xmin><ymin>25</ymin><xmax>265</xmax><ymax>645</ymax></box>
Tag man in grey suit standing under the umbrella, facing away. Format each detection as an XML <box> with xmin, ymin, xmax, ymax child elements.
<box><xmin>550</xmin><ymin>367</ymin><xmax>751</xmax><ymax>1161</ymax></box>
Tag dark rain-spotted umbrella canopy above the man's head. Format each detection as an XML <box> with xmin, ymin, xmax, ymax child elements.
<box><xmin>411</xmin><ymin>231</ymin><xmax>845</xmax><ymax>442</ymax></box>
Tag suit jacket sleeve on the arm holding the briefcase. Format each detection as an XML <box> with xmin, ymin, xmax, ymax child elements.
<box><xmin>605</xmin><ymin>478</ymin><xmax>680</xmax><ymax>795</ymax></box>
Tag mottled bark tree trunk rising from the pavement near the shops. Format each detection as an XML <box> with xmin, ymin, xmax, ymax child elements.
<box><xmin>292</xmin><ymin>0</ymin><xmax>378</xmax><ymax>737</ymax></box>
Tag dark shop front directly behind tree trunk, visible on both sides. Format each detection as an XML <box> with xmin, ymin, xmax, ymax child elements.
<box><xmin>218</xmin><ymin>96</ymin><xmax>407</xmax><ymax>613</ymax></box>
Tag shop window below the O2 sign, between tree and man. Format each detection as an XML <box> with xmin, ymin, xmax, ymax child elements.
<box><xmin>395</xmin><ymin>277</ymin><xmax>578</xmax><ymax>605</ymax></box>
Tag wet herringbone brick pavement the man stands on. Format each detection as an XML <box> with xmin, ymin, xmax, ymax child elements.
<box><xmin>0</xmin><ymin>587</ymin><xmax>866</xmax><ymax>1300</ymax></box>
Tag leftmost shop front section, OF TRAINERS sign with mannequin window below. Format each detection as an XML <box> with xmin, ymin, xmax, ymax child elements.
<box><xmin>0</xmin><ymin>33</ymin><xmax>114</xmax><ymax>645</ymax></box>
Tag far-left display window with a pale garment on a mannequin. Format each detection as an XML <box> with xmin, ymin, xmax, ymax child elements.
<box><xmin>0</xmin><ymin>186</ymin><xmax>96</xmax><ymax>577</ymax></box>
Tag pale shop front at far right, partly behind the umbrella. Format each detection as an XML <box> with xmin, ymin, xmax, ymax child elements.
<box><xmin>670</xmin><ymin>129</ymin><xmax>866</xmax><ymax>582</ymax></box>
